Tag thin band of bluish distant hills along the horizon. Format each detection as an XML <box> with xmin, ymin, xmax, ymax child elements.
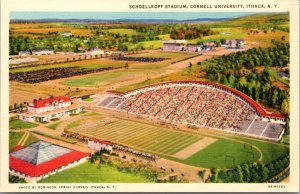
<box><xmin>10</xmin><ymin>18</ymin><xmax>232</xmax><ymax>23</ymax></box>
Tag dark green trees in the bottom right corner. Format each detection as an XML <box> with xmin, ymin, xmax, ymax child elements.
<box><xmin>209</xmin><ymin>154</ymin><xmax>290</xmax><ymax>183</ymax></box>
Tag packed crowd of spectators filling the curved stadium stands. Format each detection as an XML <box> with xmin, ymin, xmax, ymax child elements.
<box><xmin>120</xmin><ymin>86</ymin><xmax>253</xmax><ymax>129</ymax></box>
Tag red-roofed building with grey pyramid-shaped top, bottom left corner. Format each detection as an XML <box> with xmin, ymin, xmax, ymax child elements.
<box><xmin>9</xmin><ymin>141</ymin><xmax>90</xmax><ymax>183</ymax></box>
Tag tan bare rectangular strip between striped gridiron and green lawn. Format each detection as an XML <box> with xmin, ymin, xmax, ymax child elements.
<box><xmin>172</xmin><ymin>137</ymin><xmax>217</xmax><ymax>160</ymax></box>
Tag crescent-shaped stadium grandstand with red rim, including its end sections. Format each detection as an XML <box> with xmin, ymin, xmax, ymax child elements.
<box><xmin>98</xmin><ymin>81</ymin><xmax>285</xmax><ymax>141</ymax></box>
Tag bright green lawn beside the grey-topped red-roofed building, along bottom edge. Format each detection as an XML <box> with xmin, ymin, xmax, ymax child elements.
<box><xmin>40</xmin><ymin>162</ymin><xmax>149</xmax><ymax>183</ymax></box>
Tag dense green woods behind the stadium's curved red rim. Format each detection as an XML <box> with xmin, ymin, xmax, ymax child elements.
<box><xmin>205</xmin><ymin>43</ymin><xmax>289</xmax><ymax>114</ymax></box>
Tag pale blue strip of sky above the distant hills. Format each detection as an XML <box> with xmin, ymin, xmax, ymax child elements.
<box><xmin>10</xmin><ymin>12</ymin><xmax>255</xmax><ymax>20</ymax></box>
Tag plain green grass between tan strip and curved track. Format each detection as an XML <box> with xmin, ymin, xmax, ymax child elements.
<box><xmin>183</xmin><ymin>139</ymin><xmax>260</xmax><ymax>168</ymax></box>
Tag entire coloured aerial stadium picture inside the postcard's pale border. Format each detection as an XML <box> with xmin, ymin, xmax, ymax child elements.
<box><xmin>7</xmin><ymin>11</ymin><xmax>290</xmax><ymax>184</ymax></box>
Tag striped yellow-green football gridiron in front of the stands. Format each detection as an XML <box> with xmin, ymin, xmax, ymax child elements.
<box><xmin>70</xmin><ymin>120</ymin><xmax>201</xmax><ymax>155</ymax></box>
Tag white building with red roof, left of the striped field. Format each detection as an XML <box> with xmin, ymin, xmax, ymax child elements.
<box><xmin>19</xmin><ymin>96</ymin><xmax>83</xmax><ymax>122</ymax></box>
